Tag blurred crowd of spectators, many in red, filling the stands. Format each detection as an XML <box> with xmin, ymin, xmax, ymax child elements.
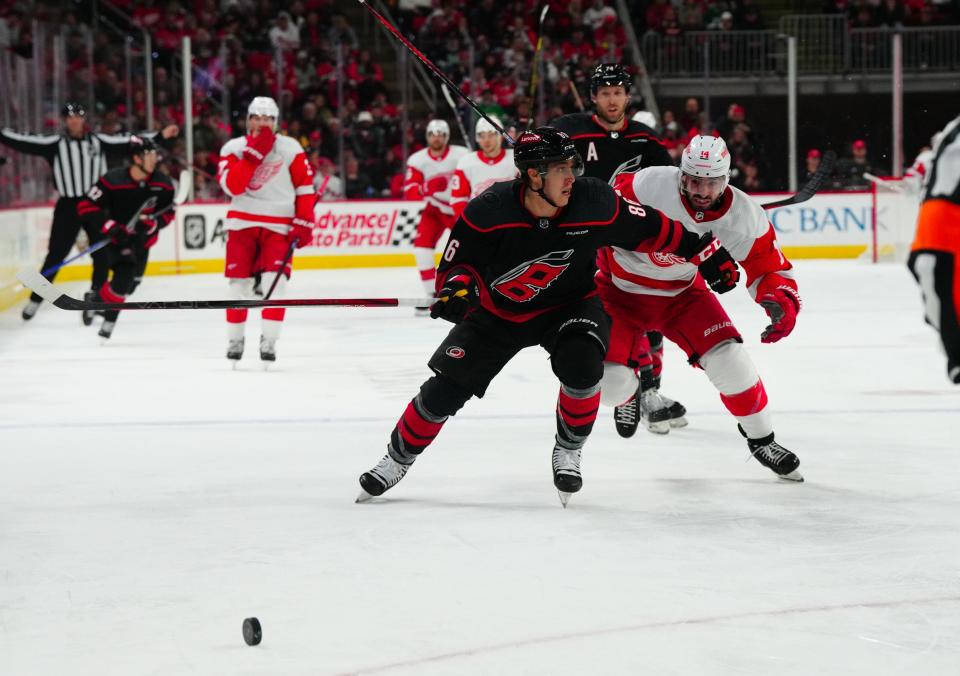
<box><xmin>0</xmin><ymin>0</ymin><xmax>960</xmax><ymax>199</ymax></box>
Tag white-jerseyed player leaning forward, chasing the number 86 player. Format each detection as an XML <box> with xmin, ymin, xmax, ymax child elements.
<box><xmin>596</xmin><ymin>136</ymin><xmax>803</xmax><ymax>481</ymax></box>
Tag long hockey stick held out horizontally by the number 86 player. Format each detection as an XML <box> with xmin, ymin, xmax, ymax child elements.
<box><xmin>17</xmin><ymin>270</ymin><xmax>435</xmax><ymax>312</ymax></box>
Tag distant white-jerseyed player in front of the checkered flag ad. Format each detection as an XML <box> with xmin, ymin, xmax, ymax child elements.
<box><xmin>403</xmin><ymin>120</ymin><xmax>470</xmax><ymax>315</ymax></box>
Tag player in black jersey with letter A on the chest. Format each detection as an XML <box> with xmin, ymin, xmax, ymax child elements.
<box><xmin>551</xmin><ymin>63</ymin><xmax>687</xmax><ymax>437</ymax></box>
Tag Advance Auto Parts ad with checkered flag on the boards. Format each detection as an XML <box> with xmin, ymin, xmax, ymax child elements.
<box><xmin>173</xmin><ymin>201</ymin><xmax>425</xmax><ymax>260</ymax></box>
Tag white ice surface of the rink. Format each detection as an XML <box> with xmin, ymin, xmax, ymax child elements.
<box><xmin>0</xmin><ymin>261</ymin><xmax>960</xmax><ymax>676</ymax></box>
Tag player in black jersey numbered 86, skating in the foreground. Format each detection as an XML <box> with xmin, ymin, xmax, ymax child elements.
<box><xmin>357</xmin><ymin>127</ymin><xmax>739</xmax><ymax>505</ymax></box>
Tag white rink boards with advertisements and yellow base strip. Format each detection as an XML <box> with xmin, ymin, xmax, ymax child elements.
<box><xmin>0</xmin><ymin>192</ymin><xmax>913</xmax><ymax>309</ymax></box>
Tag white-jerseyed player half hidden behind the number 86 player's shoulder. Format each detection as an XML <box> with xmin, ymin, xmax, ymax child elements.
<box><xmin>450</xmin><ymin>115</ymin><xmax>519</xmax><ymax>218</ymax></box>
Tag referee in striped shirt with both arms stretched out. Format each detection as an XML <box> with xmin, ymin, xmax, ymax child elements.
<box><xmin>0</xmin><ymin>102</ymin><xmax>180</xmax><ymax>320</ymax></box>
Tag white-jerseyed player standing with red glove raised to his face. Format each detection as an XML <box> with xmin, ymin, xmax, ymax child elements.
<box><xmin>217</xmin><ymin>96</ymin><xmax>316</xmax><ymax>366</ymax></box>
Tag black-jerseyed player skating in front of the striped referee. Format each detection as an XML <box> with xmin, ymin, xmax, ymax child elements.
<box><xmin>77</xmin><ymin>136</ymin><xmax>174</xmax><ymax>339</ymax></box>
